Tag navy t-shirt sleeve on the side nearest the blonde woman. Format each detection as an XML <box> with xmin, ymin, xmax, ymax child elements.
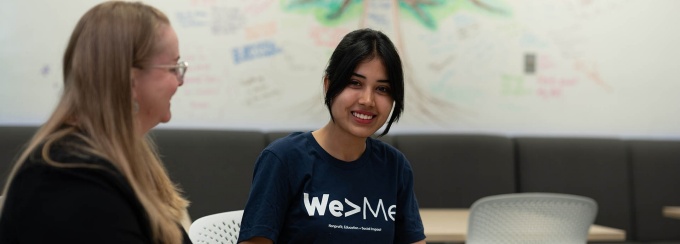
<box><xmin>239</xmin><ymin>150</ymin><xmax>292</xmax><ymax>242</ymax></box>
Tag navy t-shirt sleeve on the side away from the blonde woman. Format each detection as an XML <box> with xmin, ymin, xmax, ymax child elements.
<box><xmin>394</xmin><ymin>156</ymin><xmax>425</xmax><ymax>243</ymax></box>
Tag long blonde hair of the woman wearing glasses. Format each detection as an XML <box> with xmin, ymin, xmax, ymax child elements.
<box><xmin>3</xmin><ymin>1</ymin><xmax>188</xmax><ymax>243</ymax></box>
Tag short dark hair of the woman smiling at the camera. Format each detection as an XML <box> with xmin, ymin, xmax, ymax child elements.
<box><xmin>324</xmin><ymin>28</ymin><xmax>404</xmax><ymax>136</ymax></box>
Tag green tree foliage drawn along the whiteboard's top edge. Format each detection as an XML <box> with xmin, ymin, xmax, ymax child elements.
<box><xmin>281</xmin><ymin>0</ymin><xmax>512</xmax><ymax>30</ymax></box>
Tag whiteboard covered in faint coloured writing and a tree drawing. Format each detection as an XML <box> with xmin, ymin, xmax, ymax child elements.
<box><xmin>0</xmin><ymin>0</ymin><xmax>680</xmax><ymax>138</ymax></box>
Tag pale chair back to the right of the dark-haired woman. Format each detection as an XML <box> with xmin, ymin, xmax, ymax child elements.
<box><xmin>466</xmin><ymin>193</ymin><xmax>597</xmax><ymax>244</ymax></box>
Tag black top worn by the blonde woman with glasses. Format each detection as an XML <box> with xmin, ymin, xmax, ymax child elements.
<box><xmin>0</xmin><ymin>137</ymin><xmax>191</xmax><ymax>244</ymax></box>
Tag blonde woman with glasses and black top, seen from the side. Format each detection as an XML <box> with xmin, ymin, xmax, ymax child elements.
<box><xmin>0</xmin><ymin>1</ymin><xmax>190</xmax><ymax>243</ymax></box>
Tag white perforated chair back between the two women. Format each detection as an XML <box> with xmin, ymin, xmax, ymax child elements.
<box><xmin>189</xmin><ymin>210</ymin><xmax>243</xmax><ymax>244</ymax></box>
